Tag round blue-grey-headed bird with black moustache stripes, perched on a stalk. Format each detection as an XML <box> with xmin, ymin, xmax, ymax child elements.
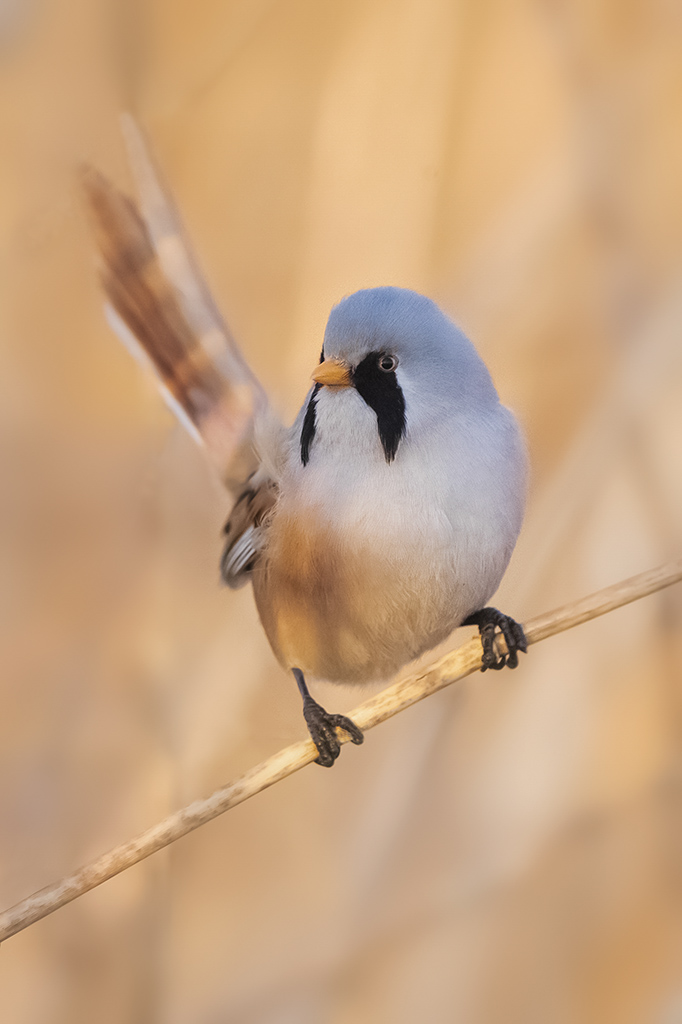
<box><xmin>82</xmin><ymin>116</ymin><xmax>528</xmax><ymax>767</ymax></box>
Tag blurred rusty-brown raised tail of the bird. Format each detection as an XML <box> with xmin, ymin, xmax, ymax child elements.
<box><xmin>82</xmin><ymin>117</ymin><xmax>267</xmax><ymax>489</ymax></box>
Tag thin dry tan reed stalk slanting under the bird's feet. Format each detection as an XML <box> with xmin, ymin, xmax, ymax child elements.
<box><xmin>0</xmin><ymin>558</ymin><xmax>682</xmax><ymax>942</ymax></box>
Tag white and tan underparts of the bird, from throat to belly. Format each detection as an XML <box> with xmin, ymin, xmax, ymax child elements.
<box><xmin>254</xmin><ymin>380</ymin><xmax>524</xmax><ymax>682</ymax></box>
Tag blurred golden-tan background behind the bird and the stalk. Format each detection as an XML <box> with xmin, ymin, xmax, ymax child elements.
<box><xmin>0</xmin><ymin>0</ymin><xmax>682</xmax><ymax>1024</ymax></box>
